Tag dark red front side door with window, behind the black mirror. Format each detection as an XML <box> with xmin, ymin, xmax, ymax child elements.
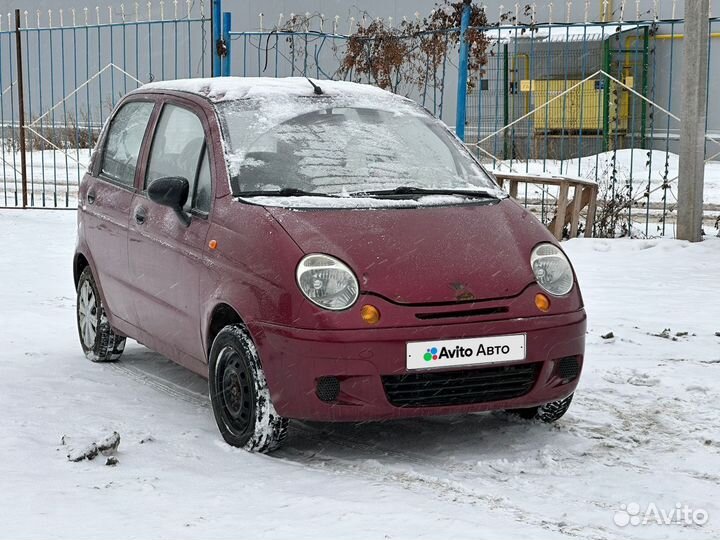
<box><xmin>129</xmin><ymin>98</ymin><xmax>212</xmax><ymax>363</ymax></box>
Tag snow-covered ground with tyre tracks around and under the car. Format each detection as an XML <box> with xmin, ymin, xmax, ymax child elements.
<box><xmin>0</xmin><ymin>210</ymin><xmax>720</xmax><ymax>540</ymax></box>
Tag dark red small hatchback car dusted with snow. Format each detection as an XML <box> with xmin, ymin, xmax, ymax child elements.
<box><xmin>74</xmin><ymin>78</ymin><xmax>586</xmax><ymax>452</ymax></box>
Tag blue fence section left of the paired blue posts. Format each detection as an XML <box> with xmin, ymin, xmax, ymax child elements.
<box><xmin>0</xmin><ymin>0</ymin><xmax>211</xmax><ymax>208</ymax></box>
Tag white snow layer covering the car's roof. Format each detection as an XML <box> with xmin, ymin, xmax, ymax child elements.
<box><xmin>140</xmin><ymin>77</ymin><xmax>407</xmax><ymax>102</ymax></box>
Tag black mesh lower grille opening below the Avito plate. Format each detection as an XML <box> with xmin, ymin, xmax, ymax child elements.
<box><xmin>382</xmin><ymin>363</ymin><xmax>541</xmax><ymax>407</ymax></box>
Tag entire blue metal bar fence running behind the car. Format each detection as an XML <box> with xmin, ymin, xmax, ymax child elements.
<box><xmin>0</xmin><ymin>1</ymin><xmax>720</xmax><ymax>236</ymax></box>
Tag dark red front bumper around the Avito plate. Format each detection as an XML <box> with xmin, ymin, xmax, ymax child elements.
<box><xmin>250</xmin><ymin>309</ymin><xmax>586</xmax><ymax>422</ymax></box>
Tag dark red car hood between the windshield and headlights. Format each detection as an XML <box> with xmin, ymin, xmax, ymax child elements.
<box><xmin>266</xmin><ymin>199</ymin><xmax>552</xmax><ymax>304</ymax></box>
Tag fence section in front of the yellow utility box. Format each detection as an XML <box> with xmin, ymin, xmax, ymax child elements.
<box><xmin>467</xmin><ymin>19</ymin><xmax>720</xmax><ymax>236</ymax></box>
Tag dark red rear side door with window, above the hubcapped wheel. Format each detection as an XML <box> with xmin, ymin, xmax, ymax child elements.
<box><xmin>80</xmin><ymin>98</ymin><xmax>155</xmax><ymax>325</ymax></box>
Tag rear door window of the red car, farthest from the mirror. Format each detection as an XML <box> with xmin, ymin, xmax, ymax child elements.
<box><xmin>100</xmin><ymin>101</ymin><xmax>155</xmax><ymax>187</ymax></box>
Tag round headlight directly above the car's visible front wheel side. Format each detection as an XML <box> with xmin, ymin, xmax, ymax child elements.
<box><xmin>296</xmin><ymin>254</ymin><xmax>359</xmax><ymax>311</ymax></box>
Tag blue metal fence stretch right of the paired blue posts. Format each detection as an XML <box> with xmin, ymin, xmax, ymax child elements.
<box><xmin>223</xmin><ymin>10</ymin><xmax>720</xmax><ymax>236</ymax></box>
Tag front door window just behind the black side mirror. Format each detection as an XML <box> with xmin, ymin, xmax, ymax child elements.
<box><xmin>144</xmin><ymin>105</ymin><xmax>205</xmax><ymax>210</ymax></box>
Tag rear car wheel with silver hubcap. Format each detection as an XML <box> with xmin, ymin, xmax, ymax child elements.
<box><xmin>75</xmin><ymin>266</ymin><xmax>125</xmax><ymax>362</ymax></box>
